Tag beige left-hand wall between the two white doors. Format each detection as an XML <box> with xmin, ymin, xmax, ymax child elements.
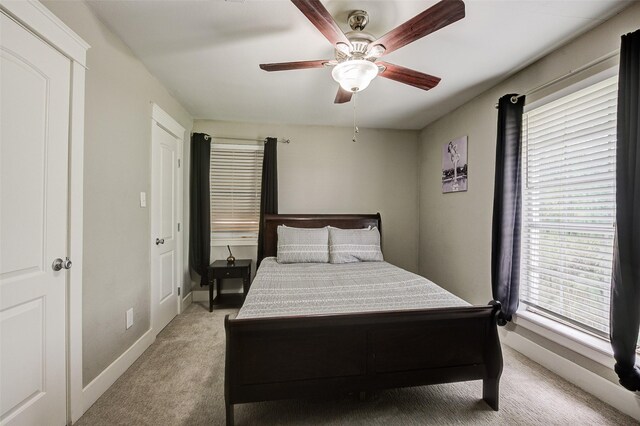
<box><xmin>44</xmin><ymin>1</ymin><xmax>192</xmax><ymax>385</ymax></box>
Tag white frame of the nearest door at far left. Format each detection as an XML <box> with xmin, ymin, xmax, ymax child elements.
<box><xmin>0</xmin><ymin>0</ymin><xmax>91</xmax><ymax>423</ymax></box>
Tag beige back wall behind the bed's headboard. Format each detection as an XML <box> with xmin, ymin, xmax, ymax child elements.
<box><xmin>193</xmin><ymin>120</ymin><xmax>418</xmax><ymax>292</ymax></box>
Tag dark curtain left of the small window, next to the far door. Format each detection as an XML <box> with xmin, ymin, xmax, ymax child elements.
<box><xmin>189</xmin><ymin>133</ymin><xmax>211</xmax><ymax>286</ymax></box>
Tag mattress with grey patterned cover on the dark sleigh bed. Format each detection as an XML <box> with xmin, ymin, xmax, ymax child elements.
<box><xmin>237</xmin><ymin>257</ymin><xmax>469</xmax><ymax>319</ymax></box>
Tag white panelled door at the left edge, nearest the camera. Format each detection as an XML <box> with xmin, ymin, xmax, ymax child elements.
<box><xmin>0</xmin><ymin>13</ymin><xmax>71</xmax><ymax>425</ymax></box>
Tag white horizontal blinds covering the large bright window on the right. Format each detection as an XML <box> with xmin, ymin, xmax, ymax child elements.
<box><xmin>520</xmin><ymin>77</ymin><xmax>617</xmax><ymax>338</ymax></box>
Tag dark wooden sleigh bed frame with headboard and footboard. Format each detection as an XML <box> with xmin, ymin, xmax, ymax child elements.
<box><xmin>224</xmin><ymin>213</ymin><xmax>502</xmax><ymax>425</ymax></box>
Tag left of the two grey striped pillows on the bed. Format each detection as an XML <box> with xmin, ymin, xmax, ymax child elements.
<box><xmin>277</xmin><ymin>225</ymin><xmax>329</xmax><ymax>263</ymax></box>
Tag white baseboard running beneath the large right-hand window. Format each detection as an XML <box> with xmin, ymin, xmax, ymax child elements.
<box><xmin>500</xmin><ymin>331</ymin><xmax>640</xmax><ymax>420</ymax></box>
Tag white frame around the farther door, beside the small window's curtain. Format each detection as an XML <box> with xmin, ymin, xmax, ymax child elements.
<box><xmin>147</xmin><ymin>102</ymin><xmax>186</xmax><ymax>337</ymax></box>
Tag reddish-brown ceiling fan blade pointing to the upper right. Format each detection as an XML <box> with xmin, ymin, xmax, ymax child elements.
<box><xmin>369</xmin><ymin>0</ymin><xmax>464</xmax><ymax>55</ymax></box>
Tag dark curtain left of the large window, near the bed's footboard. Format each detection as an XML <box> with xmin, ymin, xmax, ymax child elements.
<box><xmin>491</xmin><ymin>94</ymin><xmax>524</xmax><ymax>325</ymax></box>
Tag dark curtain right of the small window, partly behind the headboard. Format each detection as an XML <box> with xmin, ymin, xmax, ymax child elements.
<box><xmin>258</xmin><ymin>138</ymin><xmax>278</xmax><ymax>266</ymax></box>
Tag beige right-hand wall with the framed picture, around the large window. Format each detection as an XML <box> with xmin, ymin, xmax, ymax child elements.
<box><xmin>419</xmin><ymin>3</ymin><xmax>640</xmax><ymax>382</ymax></box>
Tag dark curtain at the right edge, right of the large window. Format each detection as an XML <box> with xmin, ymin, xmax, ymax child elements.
<box><xmin>610</xmin><ymin>30</ymin><xmax>640</xmax><ymax>391</ymax></box>
